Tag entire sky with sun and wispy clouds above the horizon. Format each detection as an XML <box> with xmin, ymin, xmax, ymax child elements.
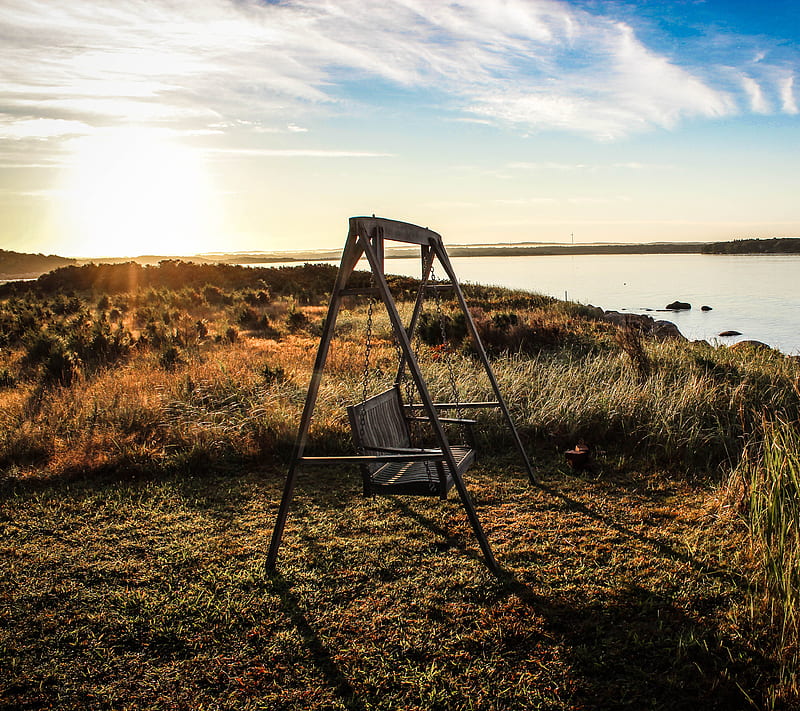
<box><xmin>0</xmin><ymin>0</ymin><xmax>800</xmax><ymax>257</ymax></box>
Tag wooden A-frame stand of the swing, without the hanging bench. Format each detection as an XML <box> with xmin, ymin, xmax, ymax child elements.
<box><xmin>267</xmin><ymin>217</ymin><xmax>536</xmax><ymax>572</ymax></box>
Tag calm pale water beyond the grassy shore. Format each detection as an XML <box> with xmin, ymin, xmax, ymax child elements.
<box><xmin>258</xmin><ymin>254</ymin><xmax>800</xmax><ymax>355</ymax></box>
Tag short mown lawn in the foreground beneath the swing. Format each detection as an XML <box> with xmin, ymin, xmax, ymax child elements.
<box><xmin>0</xmin><ymin>457</ymin><xmax>775</xmax><ymax>709</ymax></box>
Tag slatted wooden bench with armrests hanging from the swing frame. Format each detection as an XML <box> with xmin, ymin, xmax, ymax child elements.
<box><xmin>347</xmin><ymin>385</ymin><xmax>475</xmax><ymax>499</ymax></box>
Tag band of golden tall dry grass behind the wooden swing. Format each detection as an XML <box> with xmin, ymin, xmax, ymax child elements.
<box><xmin>0</xmin><ymin>294</ymin><xmax>800</xmax><ymax>484</ymax></box>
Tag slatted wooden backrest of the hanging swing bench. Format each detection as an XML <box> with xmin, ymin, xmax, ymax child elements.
<box><xmin>347</xmin><ymin>385</ymin><xmax>411</xmax><ymax>468</ymax></box>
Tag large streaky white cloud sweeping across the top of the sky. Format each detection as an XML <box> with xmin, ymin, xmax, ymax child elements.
<box><xmin>0</xmin><ymin>0</ymin><xmax>797</xmax><ymax>145</ymax></box>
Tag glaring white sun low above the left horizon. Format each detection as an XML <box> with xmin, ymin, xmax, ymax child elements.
<box><xmin>62</xmin><ymin>130</ymin><xmax>218</xmax><ymax>257</ymax></box>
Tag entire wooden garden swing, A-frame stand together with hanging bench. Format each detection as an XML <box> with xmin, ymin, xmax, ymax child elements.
<box><xmin>267</xmin><ymin>216</ymin><xmax>536</xmax><ymax>572</ymax></box>
